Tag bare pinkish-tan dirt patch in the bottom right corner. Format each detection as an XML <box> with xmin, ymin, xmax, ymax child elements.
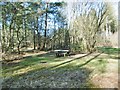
<box><xmin>92</xmin><ymin>53</ymin><xmax>118</xmax><ymax>88</ymax></box>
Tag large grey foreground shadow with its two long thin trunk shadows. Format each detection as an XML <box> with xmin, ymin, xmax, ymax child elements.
<box><xmin>3</xmin><ymin>54</ymin><xmax>100</xmax><ymax>88</ymax></box>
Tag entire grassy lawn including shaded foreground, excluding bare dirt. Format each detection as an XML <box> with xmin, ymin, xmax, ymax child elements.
<box><xmin>2</xmin><ymin>48</ymin><xmax>119</xmax><ymax>88</ymax></box>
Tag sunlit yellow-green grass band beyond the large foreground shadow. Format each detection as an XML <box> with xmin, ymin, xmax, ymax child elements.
<box><xmin>3</xmin><ymin>49</ymin><xmax>117</xmax><ymax>86</ymax></box>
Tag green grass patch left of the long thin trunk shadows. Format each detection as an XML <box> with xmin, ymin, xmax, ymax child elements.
<box><xmin>2</xmin><ymin>54</ymin><xmax>70</xmax><ymax>77</ymax></box>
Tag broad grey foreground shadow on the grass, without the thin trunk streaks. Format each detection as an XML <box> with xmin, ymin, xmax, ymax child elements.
<box><xmin>3</xmin><ymin>66</ymin><xmax>92</xmax><ymax>88</ymax></box>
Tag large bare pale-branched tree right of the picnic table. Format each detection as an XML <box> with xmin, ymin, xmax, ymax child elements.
<box><xmin>70</xmin><ymin>2</ymin><xmax>117</xmax><ymax>52</ymax></box>
